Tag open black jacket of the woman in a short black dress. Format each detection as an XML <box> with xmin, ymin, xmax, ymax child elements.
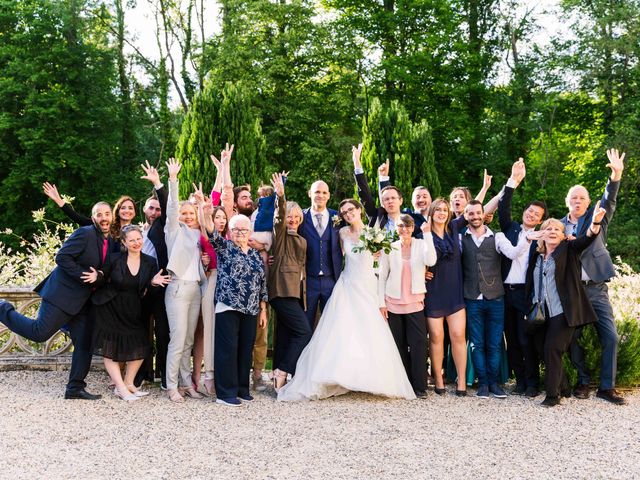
<box><xmin>91</xmin><ymin>252</ymin><xmax>158</xmax><ymax>305</ymax></box>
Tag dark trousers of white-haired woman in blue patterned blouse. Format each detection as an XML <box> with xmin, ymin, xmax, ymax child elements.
<box><xmin>213</xmin><ymin>310</ymin><xmax>257</xmax><ymax>399</ymax></box>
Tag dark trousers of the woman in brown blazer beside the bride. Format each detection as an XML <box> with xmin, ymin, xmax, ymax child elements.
<box><xmin>269</xmin><ymin>297</ymin><xmax>312</xmax><ymax>375</ymax></box>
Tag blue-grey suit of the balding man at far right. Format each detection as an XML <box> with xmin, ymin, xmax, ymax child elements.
<box><xmin>562</xmin><ymin>180</ymin><xmax>620</xmax><ymax>390</ymax></box>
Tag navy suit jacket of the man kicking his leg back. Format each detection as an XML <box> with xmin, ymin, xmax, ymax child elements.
<box><xmin>35</xmin><ymin>225</ymin><xmax>113</xmax><ymax>315</ymax></box>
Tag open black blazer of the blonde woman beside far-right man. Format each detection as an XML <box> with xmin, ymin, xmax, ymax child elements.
<box><xmin>525</xmin><ymin>235</ymin><xmax>597</xmax><ymax>327</ymax></box>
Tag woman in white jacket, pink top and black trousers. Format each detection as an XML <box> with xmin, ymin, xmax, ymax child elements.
<box><xmin>378</xmin><ymin>215</ymin><xmax>437</xmax><ymax>397</ymax></box>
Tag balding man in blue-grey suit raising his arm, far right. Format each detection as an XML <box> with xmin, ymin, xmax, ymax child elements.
<box><xmin>562</xmin><ymin>149</ymin><xmax>626</xmax><ymax>405</ymax></box>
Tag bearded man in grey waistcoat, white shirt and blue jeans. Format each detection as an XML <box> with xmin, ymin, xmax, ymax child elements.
<box><xmin>461</xmin><ymin>200</ymin><xmax>529</xmax><ymax>398</ymax></box>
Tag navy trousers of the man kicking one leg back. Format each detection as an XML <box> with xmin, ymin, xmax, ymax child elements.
<box><xmin>0</xmin><ymin>300</ymin><xmax>93</xmax><ymax>393</ymax></box>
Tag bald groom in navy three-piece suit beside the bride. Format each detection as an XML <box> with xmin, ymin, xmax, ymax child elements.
<box><xmin>301</xmin><ymin>180</ymin><xmax>342</xmax><ymax>330</ymax></box>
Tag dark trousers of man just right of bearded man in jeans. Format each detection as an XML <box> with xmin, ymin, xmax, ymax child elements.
<box><xmin>504</xmin><ymin>284</ymin><xmax>529</xmax><ymax>386</ymax></box>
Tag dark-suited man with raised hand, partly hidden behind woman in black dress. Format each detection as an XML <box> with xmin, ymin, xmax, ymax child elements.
<box><xmin>134</xmin><ymin>162</ymin><xmax>169</xmax><ymax>388</ymax></box>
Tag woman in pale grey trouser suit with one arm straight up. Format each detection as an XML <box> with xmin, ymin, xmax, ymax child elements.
<box><xmin>164</xmin><ymin>159</ymin><xmax>206</xmax><ymax>402</ymax></box>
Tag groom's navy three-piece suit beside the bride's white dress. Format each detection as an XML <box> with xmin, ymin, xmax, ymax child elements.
<box><xmin>300</xmin><ymin>208</ymin><xmax>342</xmax><ymax>329</ymax></box>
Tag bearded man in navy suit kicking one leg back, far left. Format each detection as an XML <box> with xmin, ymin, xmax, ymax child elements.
<box><xmin>0</xmin><ymin>202</ymin><xmax>112</xmax><ymax>400</ymax></box>
